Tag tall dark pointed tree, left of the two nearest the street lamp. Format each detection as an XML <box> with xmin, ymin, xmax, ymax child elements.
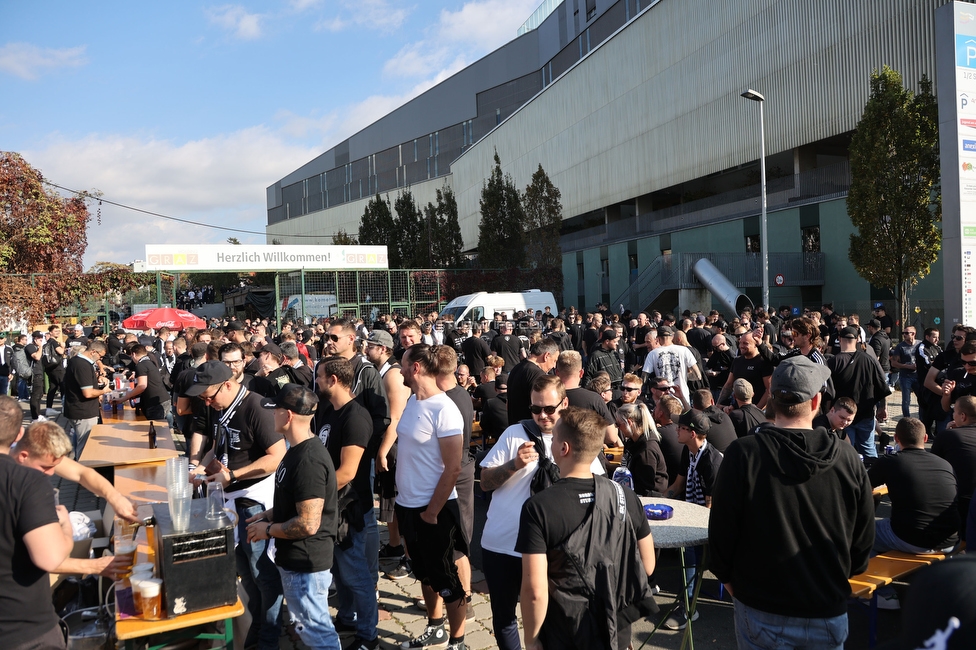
<box><xmin>478</xmin><ymin>150</ymin><xmax>525</xmax><ymax>269</ymax></box>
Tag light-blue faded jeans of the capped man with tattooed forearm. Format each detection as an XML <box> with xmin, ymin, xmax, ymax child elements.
<box><xmin>275</xmin><ymin>567</ymin><xmax>342</xmax><ymax>650</ymax></box>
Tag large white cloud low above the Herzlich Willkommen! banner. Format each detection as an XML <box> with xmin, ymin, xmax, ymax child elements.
<box><xmin>21</xmin><ymin>126</ymin><xmax>321</xmax><ymax>268</ymax></box>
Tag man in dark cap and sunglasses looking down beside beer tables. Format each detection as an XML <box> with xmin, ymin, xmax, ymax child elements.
<box><xmin>184</xmin><ymin>361</ymin><xmax>285</xmax><ymax>650</ymax></box>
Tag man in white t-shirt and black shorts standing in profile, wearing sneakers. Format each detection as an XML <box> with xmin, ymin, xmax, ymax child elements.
<box><xmin>396</xmin><ymin>343</ymin><xmax>467</xmax><ymax>650</ymax></box>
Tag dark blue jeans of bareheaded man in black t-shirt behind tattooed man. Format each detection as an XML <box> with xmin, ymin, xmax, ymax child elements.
<box><xmin>336</xmin><ymin>510</ymin><xmax>379</xmax><ymax>641</ymax></box>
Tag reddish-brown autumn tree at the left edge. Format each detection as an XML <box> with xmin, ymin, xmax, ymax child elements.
<box><xmin>0</xmin><ymin>151</ymin><xmax>99</xmax><ymax>273</ymax></box>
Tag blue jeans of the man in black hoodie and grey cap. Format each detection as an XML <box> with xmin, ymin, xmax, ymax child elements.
<box><xmin>734</xmin><ymin>600</ymin><xmax>847</xmax><ymax>650</ymax></box>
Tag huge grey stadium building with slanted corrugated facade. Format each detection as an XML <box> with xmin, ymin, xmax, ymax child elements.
<box><xmin>267</xmin><ymin>0</ymin><xmax>945</xmax><ymax>322</ymax></box>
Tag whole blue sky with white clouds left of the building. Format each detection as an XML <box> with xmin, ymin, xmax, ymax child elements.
<box><xmin>0</xmin><ymin>0</ymin><xmax>540</xmax><ymax>269</ymax></box>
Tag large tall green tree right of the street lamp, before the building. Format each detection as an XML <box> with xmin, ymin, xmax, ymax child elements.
<box><xmin>847</xmin><ymin>66</ymin><xmax>942</xmax><ymax>325</ymax></box>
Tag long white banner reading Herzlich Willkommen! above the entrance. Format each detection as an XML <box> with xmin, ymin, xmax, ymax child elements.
<box><xmin>145</xmin><ymin>244</ymin><xmax>388</xmax><ymax>273</ymax></box>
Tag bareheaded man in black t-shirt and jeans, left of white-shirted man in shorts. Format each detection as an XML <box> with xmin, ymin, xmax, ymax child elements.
<box><xmin>312</xmin><ymin>356</ymin><xmax>379</xmax><ymax>648</ymax></box>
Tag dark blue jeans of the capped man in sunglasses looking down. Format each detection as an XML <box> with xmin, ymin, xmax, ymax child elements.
<box><xmin>235</xmin><ymin>499</ymin><xmax>282</xmax><ymax>650</ymax></box>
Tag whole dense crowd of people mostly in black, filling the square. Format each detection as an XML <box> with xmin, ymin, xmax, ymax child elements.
<box><xmin>0</xmin><ymin>304</ymin><xmax>976</xmax><ymax>650</ymax></box>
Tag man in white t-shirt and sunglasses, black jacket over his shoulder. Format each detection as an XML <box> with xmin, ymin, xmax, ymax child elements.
<box><xmin>481</xmin><ymin>375</ymin><xmax>603</xmax><ymax>650</ymax></box>
